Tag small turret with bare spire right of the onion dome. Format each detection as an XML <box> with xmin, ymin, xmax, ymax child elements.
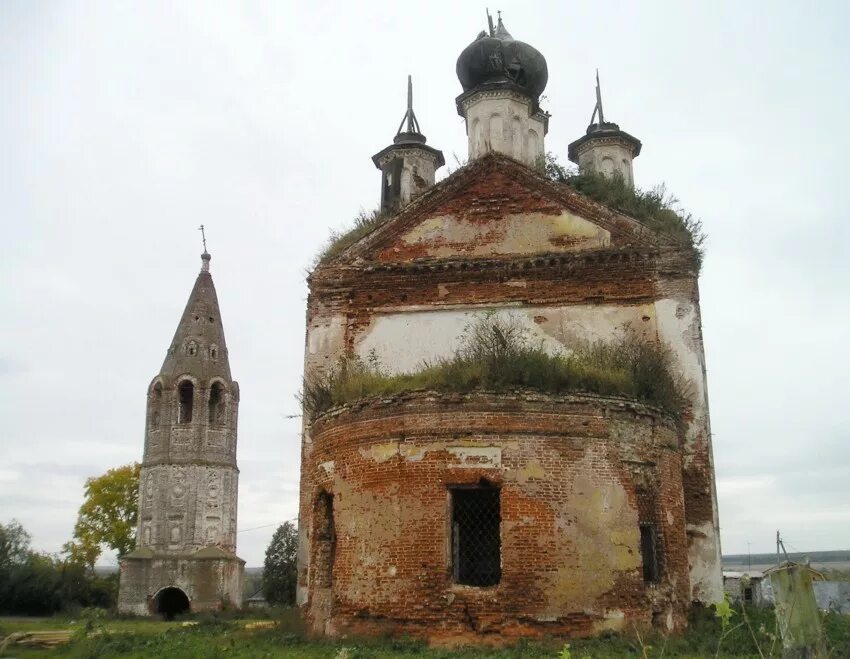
<box><xmin>567</xmin><ymin>71</ymin><xmax>641</xmax><ymax>186</ymax></box>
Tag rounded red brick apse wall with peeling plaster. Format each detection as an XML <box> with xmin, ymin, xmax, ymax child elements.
<box><xmin>301</xmin><ymin>393</ymin><xmax>689</xmax><ymax>641</ymax></box>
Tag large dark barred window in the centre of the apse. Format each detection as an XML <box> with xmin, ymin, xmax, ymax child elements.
<box><xmin>450</xmin><ymin>481</ymin><xmax>502</xmax><ymax>586</ymax></box>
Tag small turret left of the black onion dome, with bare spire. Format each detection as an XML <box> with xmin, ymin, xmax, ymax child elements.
<box><xmin>372</xmin><ymin>76</ymin><xmax>446</xmax><ymax>212</ymax></box>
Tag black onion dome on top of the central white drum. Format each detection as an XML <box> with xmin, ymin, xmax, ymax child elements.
<box><xmin>456</xmin><ymin>19</ymin><xmax>549</xmax><ymax>101</ymax></box>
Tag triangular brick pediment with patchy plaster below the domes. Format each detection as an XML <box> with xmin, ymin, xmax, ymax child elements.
<box><xmin>336</xmin><ymin>154</ymin><xmax>657</xmax><ymax>263</ymax></box>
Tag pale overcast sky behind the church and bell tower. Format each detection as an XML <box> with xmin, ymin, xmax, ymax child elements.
<box><xmin>0</xmin><ymin>0</ymin><xmax>850</xmax><ymax>566</ymax></box>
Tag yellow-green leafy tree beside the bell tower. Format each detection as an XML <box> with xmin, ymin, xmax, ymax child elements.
<box><xmin>62</xmin><ymin>463</ymin><xmax>139</xmax><ymax>568</ymax></box>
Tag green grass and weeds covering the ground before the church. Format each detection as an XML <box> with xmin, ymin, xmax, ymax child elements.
<box><xmin>3</xmin><ymin>607</ymin><xmax>850</xmax><ymax>659</ymax></box>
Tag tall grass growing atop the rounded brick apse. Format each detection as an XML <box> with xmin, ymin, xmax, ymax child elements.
<box><xmin>302</xmin><ymin>313</ymin><xmax>687</xmax><ymax>420</ymax></box>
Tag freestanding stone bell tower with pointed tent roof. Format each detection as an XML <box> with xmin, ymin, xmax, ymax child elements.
<box><xmin>118</xmin><ymin>250</ymin><xmax>244</xmax><ymax>618</ymax></box>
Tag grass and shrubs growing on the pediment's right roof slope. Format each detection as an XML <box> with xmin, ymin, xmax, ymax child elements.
<box><xmin>541</xmin><ymin>153</ymin><xmax>706</xmax><ymax>266</ymax></box>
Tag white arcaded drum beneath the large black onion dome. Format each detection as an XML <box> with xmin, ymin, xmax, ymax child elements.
<box><xmin>466</xmin><ymin>91</ymin><xmax>546</xmax><ymax>166</ymax></box>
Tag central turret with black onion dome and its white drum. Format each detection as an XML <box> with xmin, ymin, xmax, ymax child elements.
<box><xmin>456</xmin><ymin>12</ymin><xmax>549</xmax><ymax>166</ymax></box>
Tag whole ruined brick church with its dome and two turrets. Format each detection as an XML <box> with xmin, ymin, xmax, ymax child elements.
<box><xmin>294</xmin><ymin>19</ymin><xmax>721</xmax><ymax>641</ymax></box>
